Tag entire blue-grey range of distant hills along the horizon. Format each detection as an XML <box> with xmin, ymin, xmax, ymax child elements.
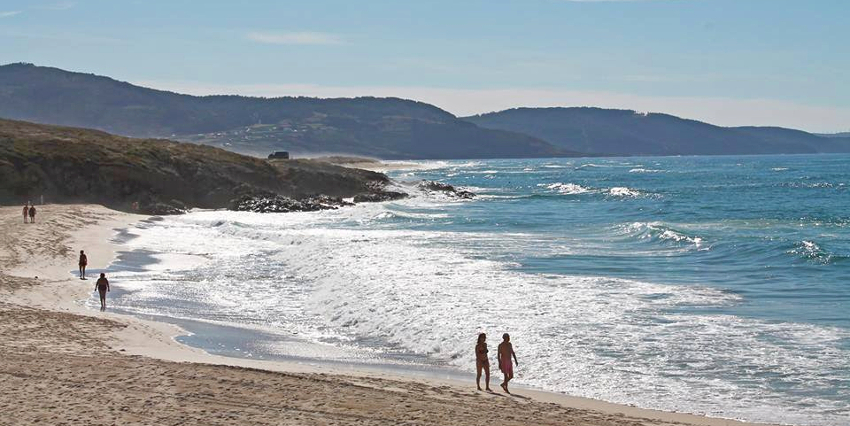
<box><xmin>0</xmin><ymin>63</ymin><xmax>850</xmax><ymax>159</ymax></box>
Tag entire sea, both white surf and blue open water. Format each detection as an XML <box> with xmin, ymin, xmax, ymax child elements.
<box><xmin>94</xmin><ymin>155</ymin><xmax>850</xmax><ymax>426</ymax></box>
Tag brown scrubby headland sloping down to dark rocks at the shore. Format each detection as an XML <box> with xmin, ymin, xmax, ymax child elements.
<box><xmin>0</xmin><ymin>120</ymin><xmax>388</xmax><ymax>211</ymax></box>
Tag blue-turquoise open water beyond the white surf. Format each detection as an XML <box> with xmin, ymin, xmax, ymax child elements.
<box><xmin>396</xmin><ymin>155</ymin><xmax>850</xmax><ymax>328</ymax></box>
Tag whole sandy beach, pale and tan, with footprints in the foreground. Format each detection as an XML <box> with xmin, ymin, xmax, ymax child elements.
<box><xmin>0</xmin><ymin>205</ymin><xmax>772</xmax><ymax>426</ymax></box>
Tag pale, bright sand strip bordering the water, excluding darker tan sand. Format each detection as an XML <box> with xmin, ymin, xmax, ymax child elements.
<box><xmin>0</xmin><ymin>205</ymin><xmax>776</xmax><ymax>426</ymax></box>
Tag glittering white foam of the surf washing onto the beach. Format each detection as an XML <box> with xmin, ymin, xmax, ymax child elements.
<box><xmin>111</xmin><ymin>207</ymin><xmax>850</xmax><ymax>426</ymax></box>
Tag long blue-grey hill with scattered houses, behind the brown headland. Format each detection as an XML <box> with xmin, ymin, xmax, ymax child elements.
<box><xmin>0</xmin><ymin>64</ymin><xmax>578</xmax><ymax>159</ymax></box>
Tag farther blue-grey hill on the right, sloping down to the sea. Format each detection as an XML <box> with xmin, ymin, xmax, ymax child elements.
<box><xmin>464</xmin><ymin>107</ymin><xmax>850</xmax><ymax>155</ymax></box>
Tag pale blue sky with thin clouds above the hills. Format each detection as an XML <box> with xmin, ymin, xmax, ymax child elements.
<box><xmin>0</xmin><ymin>0</ymin><xmax>850</xmax><ymax>132</ymax></box>
